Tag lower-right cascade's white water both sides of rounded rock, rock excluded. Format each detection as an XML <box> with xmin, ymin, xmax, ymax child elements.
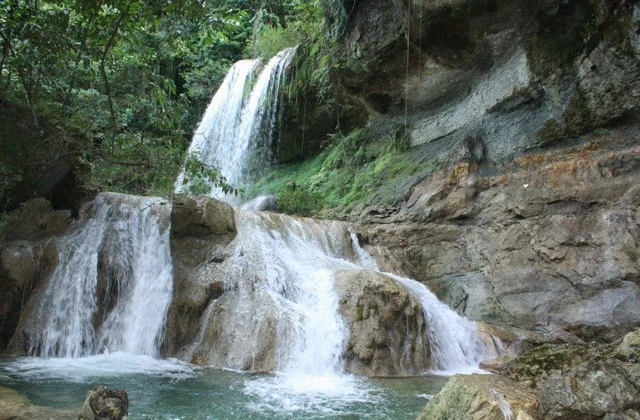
<box><xmin>187</xmin><ymin>210</ymin><xmax>497</xmax><ymax>378</ymax></box>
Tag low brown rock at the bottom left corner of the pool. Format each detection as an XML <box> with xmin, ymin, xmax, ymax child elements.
<box><xmin>0</xmin><ymin>386</ymin><xmax>77</xmax><ymax>420</ymax></box>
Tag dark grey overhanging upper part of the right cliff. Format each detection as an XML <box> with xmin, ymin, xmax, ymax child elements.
<box><xmin>335</xmin><ymin>0</ymin><xmax>640</xmax><ymax>161</ymax></box>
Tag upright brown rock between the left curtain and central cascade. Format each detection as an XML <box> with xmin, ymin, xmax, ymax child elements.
<box><xmin>163</xmin><ymin>196</ymin><xmax>236</xmax><ymax>357</ymax></box>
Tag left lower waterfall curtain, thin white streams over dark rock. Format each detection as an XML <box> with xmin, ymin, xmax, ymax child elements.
<box><xmin>26</xmin><ymin>193</ymin><xmax>173</xmax><ymax>358</ymax></box>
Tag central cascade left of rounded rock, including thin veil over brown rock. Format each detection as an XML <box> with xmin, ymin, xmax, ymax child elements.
<box><xmin>196</xmin><ymin>211</ymin><xmax>353</xmax><ymax>375</ymax></box>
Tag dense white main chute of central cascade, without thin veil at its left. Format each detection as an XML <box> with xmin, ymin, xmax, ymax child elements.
<box><xmin>221</xmin><ymin>212</ymin><xmax>352</xmax><ymax>376</ymax></box>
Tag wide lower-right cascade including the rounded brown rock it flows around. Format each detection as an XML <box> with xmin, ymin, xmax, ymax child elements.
<box><xmin>182</xmin><ymin>211</ymin><xmax>499</xmax><ymax>376</ymax></box>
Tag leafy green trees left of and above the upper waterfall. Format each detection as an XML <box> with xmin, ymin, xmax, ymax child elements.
<box><xmin>0</xmin><ymin>0</ymin><xmax>330</xmax><ymax>210</ymax></box>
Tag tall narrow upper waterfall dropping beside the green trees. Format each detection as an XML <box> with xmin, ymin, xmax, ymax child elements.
<box><xmin>175</xmin><ymin>48</ymin><xmax>296</xmax><ymax>198</ymax></box>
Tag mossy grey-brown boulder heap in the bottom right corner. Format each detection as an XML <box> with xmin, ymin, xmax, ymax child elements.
<box><xmin>502</xmin><ymin>331</ymin><xmax>640</xmax><ymax>420</ymax></box>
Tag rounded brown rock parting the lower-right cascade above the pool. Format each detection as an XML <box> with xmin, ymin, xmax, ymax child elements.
<box><xmin>335</xmin><ymin>270</ymin><xmax>430</xmax><ymax>376</ymax></box>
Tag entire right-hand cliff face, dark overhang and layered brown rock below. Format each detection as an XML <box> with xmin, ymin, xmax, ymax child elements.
<box><xmin>292</xmin><ymin>0</ymin><xmax>640</xmax><ymax>341</ymax></box>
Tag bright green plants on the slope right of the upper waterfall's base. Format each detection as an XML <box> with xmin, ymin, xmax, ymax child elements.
<box><xmin>247</xmin><ymin>129</ymin><xmax>432</xmax><ymax>216</ymax></box>
